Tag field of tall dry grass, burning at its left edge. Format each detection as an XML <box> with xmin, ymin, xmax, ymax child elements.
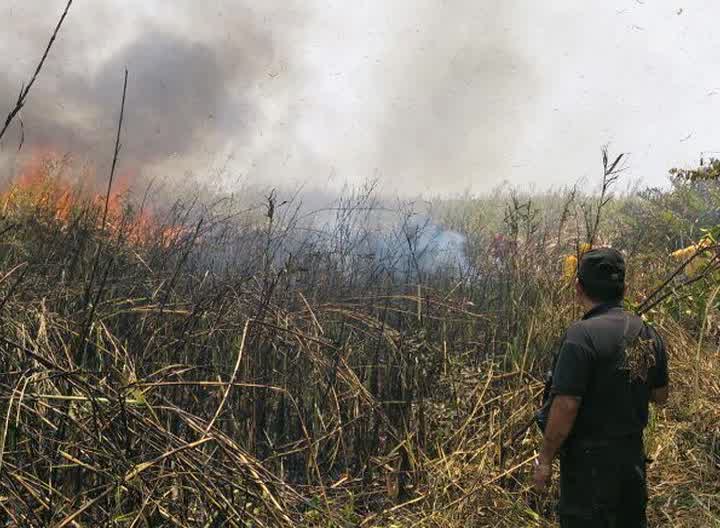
<box><xmin>0</xmin><ymin>151</ymin><xmax>720</xmax><ymax>528</ymax></box>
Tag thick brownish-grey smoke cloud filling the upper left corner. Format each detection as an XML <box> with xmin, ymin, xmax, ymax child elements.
<box><xmin>0</xmin><ymin>1</ymin><xmax>278</xmax><ymax>175</ymax></box>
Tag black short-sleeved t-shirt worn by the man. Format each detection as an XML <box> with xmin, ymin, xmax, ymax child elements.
<box><xmin>552</xmin><ymin>305</ymin><xmax>668</xmax><ymax>441</ymax></box>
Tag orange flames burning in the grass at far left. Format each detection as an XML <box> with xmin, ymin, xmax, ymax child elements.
<box><xmin>0</xmin><ymin>150</ymin><xmax>186</xmax><ymax>247</ymax></box>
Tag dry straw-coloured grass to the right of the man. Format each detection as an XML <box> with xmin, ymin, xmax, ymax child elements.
<box><xmin>647</xmin><ymin>318</ymin><xmax>720</xmax><ymax>528</ymax></box>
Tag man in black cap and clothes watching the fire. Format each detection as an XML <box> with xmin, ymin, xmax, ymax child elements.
<box><xmin>533</xmin><ymin>248</ymin><xmax>668</xmax><ymax>528</ymax></box>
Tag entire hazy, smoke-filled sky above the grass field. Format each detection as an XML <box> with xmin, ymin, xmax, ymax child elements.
<box><xmin>0</xmin><ymin>0</ymin><xmax>720</xmax><ymax>193</ymax></box>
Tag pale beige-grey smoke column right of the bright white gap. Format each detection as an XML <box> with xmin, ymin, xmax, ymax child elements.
<box><xmin>368</xmin><ymin>0</ymin><xmax>536</xmax><ymax>194</ymax></box>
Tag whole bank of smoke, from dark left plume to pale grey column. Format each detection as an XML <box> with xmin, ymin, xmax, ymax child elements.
<box><xmin>0</xmin><ymin>0</ymin><xmax>534</xmax><ymax>194</ymax></box>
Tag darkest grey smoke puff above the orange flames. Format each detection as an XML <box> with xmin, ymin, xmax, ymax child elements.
<box><xmin>93</xmin><ymin>32</ymin><xmax>270</xmax><ymax>162</ymax></box>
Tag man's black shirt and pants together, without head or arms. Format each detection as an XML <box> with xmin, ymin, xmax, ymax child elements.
<box><xmin>552</xmin><ymin>304</ymin><xmax>668</xmax><ymax>528</ymax></box>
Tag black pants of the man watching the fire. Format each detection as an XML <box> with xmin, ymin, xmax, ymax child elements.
<box><xmin>558</xmin><ymin>438</ymin><xmax>647</xmax><ymax>528</ymax></box>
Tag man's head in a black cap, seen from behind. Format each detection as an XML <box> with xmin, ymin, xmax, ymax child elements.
<box><xmin>577</xmin><ymin>248</ymin><xmax>625</xmax><ymax>304</ymax></box>
